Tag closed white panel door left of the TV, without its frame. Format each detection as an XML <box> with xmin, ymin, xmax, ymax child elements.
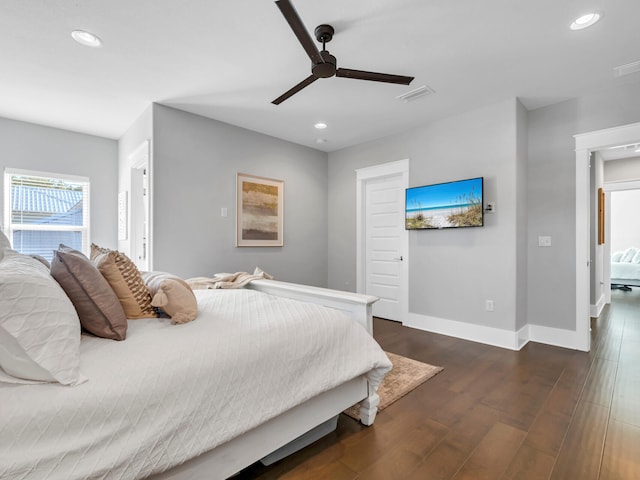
<box><xmin>364</xmin><ymin>174</ymin><xmax>406</xmax><ymax>320</ymax></box>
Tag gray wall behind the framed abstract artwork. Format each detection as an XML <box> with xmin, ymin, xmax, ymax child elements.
<box><xmin>152</xmin><ymin>105</ymin><xmax>327</xmax><ymax>286</ymax></box>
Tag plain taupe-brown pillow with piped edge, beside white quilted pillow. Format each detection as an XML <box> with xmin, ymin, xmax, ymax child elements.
<box><xmin>51</xmin><ymin>245</ymin><xmax>127</xmax><ymax>340</ymax></box>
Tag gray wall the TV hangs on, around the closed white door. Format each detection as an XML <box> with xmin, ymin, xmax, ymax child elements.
<box><xmin>329</xmin><ymin>99</ymin><xmax>526</xmax><ymax>331</ymax></box>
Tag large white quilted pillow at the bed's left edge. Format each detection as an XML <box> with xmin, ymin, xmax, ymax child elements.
<box><xmin>0</xmin><ymin>250</ymin><xmax>80</xmax><ymax>385</ymax></box>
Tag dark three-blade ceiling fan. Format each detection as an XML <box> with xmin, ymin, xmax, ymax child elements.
<box><xmin>271</xmin><ymin>0</ymin><xmax>413</xmax><ymax>105</ymax></box>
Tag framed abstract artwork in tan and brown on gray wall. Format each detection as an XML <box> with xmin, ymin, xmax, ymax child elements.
<box><xmin>236</xmin><ymin>173</ymin><xmax>284</xmax><ymax>247</ymax></box>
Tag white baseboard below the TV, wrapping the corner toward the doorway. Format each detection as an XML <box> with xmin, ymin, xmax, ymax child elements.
<box><xmin>403</xmin><ymin>313</ymin><xmax>578</xmax><ymax>350</ymax></box>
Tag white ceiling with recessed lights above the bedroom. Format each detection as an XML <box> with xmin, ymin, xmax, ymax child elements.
<box><xmin>0</xmin><ymin>0</ymin><xmax>640</xmax><ymax>151</ymax></box>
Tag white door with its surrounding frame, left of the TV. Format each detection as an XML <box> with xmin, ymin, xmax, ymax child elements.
<box><xmin>356</xmin><ymin>159</ymin><xmax>409</xmax><ymax>322</ymax></box>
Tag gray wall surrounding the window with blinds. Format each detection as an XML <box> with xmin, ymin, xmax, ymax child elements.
<box><xmin>0</xmin><ymin>117</ymin><xmax>118</xmax><ymax>251</ymax></box>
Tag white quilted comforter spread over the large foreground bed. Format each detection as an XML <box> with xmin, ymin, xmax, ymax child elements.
<box><xmin>0</xmin><ymin>290</ymin><xmax>391</xmax><ymax>480</ymax></box>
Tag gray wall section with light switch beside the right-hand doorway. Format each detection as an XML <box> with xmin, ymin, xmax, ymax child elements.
<box><xmin>527</xmin><ymin>83</ymin><xmax>640</xmax><ymax>330</ymax></box>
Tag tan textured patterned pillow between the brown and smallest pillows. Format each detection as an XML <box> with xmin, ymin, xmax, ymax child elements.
<box><xmin>91</xmin><ymin>244</ymin><xmax>157</xmax><ymax>318</ymax></box>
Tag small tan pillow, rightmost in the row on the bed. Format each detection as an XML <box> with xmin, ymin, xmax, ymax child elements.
<box><xmin>142</xmin><ymin>272</ymin><xmax>198</xmax><ymax>323</ymax></box>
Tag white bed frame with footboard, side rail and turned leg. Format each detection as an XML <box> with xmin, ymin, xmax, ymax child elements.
<box><xmin>153</xmin><ymin>280</ymin><xmax>380</xmax><ymax>480</ymax></box>
